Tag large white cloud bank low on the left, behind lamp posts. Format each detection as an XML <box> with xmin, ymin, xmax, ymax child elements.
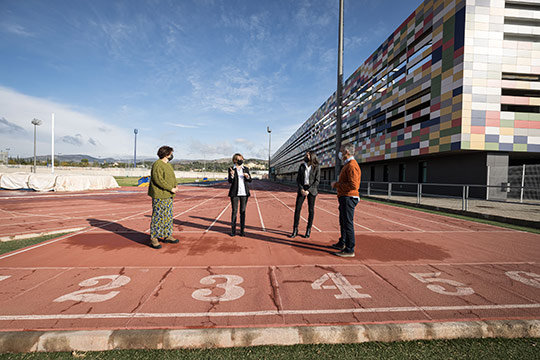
<box><xmin>0</xmin><ymin>86</ymin><xmax>141</xmax><ymax>156</ymax></box>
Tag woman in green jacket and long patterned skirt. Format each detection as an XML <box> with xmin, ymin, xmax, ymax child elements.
<box><xmin>148</xmin><ymin>146</ymin><xmax>178</xmax><ymax>249</ymax></box>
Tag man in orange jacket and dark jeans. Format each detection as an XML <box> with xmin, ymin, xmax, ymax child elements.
<box><xmin>332</xmin><ymin>144</ymin><xmax>362</xmax><ymax>257</ymax></box>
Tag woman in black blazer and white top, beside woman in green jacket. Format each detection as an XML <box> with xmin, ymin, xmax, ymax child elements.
<box><xmin>228</xmin><ymin>153</ymin><xmax>251</xmax><ymax>236</ymax></box>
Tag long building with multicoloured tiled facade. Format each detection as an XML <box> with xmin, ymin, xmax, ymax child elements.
<box><xmin>271</xmin><ymin>0</ymin><xmax>540</xmax><ymax>197</ymax></box>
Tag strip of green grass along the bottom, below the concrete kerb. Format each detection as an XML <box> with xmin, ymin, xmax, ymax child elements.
<box><xmin>0</xmin><ymin>338</ymin><xmax>540</xmax><ymax>360</ymax></box>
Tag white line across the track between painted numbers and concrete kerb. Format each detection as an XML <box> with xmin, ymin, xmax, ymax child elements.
<box><xmin>0</xmin><ymin>303</ymin><xmax>540</xmax><ymax>321</ymax></box>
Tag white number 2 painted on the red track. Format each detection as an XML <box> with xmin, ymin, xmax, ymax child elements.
<box><xmin>54</xmin><ymin>275</ymin><xmax>131</xmax><ymax>303</ymax></box>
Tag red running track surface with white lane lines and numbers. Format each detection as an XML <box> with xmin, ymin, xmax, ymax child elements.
<box><xmin>0</xmin><ymin>182</ymin><xmax>540</xmax><ymax>331</ymax></box>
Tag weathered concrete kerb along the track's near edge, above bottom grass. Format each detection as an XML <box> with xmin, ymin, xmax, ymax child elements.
<box><xmin>0</xmin><ymin>320</ymin><xmax>540</xmax><ymax>353</ymax></box>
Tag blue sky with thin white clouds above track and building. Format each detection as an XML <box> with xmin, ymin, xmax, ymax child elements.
<box><xmin>0</xmin><ymin>0</ymin><xmax>421</xmax><ymax>159</ymax></box>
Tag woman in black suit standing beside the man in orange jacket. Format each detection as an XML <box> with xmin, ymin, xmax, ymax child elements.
<box><xmin>289</xmin><ymin>151</ymin><xmax>321</xmax><ymax>238</ymax></box>
